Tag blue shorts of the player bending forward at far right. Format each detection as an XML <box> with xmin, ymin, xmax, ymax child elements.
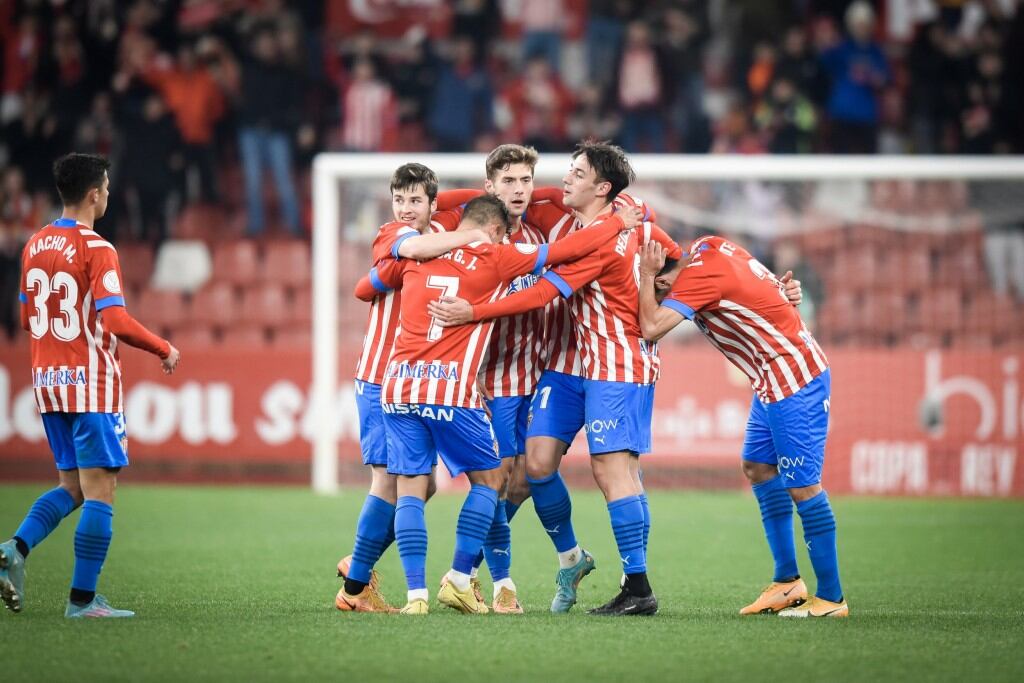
<box><xmin>743</xmin><ymin>370</ymin><xmax>831</xmax><ymax>488</ymax></box>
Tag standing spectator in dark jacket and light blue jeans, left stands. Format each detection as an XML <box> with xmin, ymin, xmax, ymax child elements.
<box><xmin>238</xmin><ymin>25</ymin><xmax>301</xmax><ymax>237</ymax></box>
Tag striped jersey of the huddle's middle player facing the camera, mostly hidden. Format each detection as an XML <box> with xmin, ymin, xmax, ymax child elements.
<box><xmin>480</xmin><ymin>221</ymin><xmax>546</xmax><ymax>398</ymax></box>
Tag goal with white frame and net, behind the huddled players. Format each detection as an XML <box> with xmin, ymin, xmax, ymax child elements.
<box><xmin>311</xmin><ymin>153</ymin><xmax>1024</xmax><ymax>495</ymax></box>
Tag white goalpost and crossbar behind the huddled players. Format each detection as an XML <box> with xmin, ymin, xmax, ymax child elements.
<box><xmin>310</xmin><ymin>153</ymin><xmax>1024</xmax><ymax>494</ymax></box>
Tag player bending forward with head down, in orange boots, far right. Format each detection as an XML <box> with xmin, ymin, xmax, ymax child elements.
<box><xmin>640</xmin><ymin>237</ymin><xmax>850</xmax><ymax>616</ymax></box>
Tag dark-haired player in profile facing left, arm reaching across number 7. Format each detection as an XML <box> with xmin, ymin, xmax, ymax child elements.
<box><xmin>431</xmin><ymin>141</ymin><xmax>681</xmax><ymax>614</ymax></box>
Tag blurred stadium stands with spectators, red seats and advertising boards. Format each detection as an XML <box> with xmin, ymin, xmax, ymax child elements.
<box><xmin>0</xmin><ymin>0</ymin><xmax>1024</xmax><ymax>497</ymax></box>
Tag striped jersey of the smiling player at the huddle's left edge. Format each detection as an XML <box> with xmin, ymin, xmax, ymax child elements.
<box><xmin>355</xmin><ymin>220</ymin><xmax>446</xmax><ymax>384</ymax></box>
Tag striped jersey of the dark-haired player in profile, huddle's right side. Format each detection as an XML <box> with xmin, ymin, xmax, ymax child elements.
<box><xmin>545</xmin><ymin>216</ymin><xmax>682</xmax><ymax>384</ymax></box>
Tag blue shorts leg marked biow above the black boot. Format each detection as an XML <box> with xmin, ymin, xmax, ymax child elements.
<box><xmin>583</xmin><ymin>380</ymin><xmax>654</xmax><ymax>456</ymax></box>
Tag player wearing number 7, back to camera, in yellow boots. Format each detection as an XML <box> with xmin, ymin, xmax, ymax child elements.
<box><xmin>359</xmin><ymin>197</ymin><xmax>639</xmax><ymax>614</ymax></box>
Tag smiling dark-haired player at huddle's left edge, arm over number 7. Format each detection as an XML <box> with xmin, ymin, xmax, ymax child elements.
<box><xmin>335</xmin><ymin>164</ymin><xmax>486</xmax><ymax>611</ymax></box>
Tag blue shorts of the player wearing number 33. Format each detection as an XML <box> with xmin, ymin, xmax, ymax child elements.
<box><xmin>43</xmin><ymin>413</ymin><xmax>128</xmax><ymax>470</ymax></box>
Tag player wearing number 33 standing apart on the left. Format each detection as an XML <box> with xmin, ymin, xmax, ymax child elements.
<box><xmin>0</xmin><ymin>154</ymin><xmax>179</xmax><ymax>617</ymax></box>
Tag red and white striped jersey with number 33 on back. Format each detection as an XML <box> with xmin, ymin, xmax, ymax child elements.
<box><xmin>19</xmin><ymin>218</ymin><xmax>125</xmax><ymax>413</ymax></box>
